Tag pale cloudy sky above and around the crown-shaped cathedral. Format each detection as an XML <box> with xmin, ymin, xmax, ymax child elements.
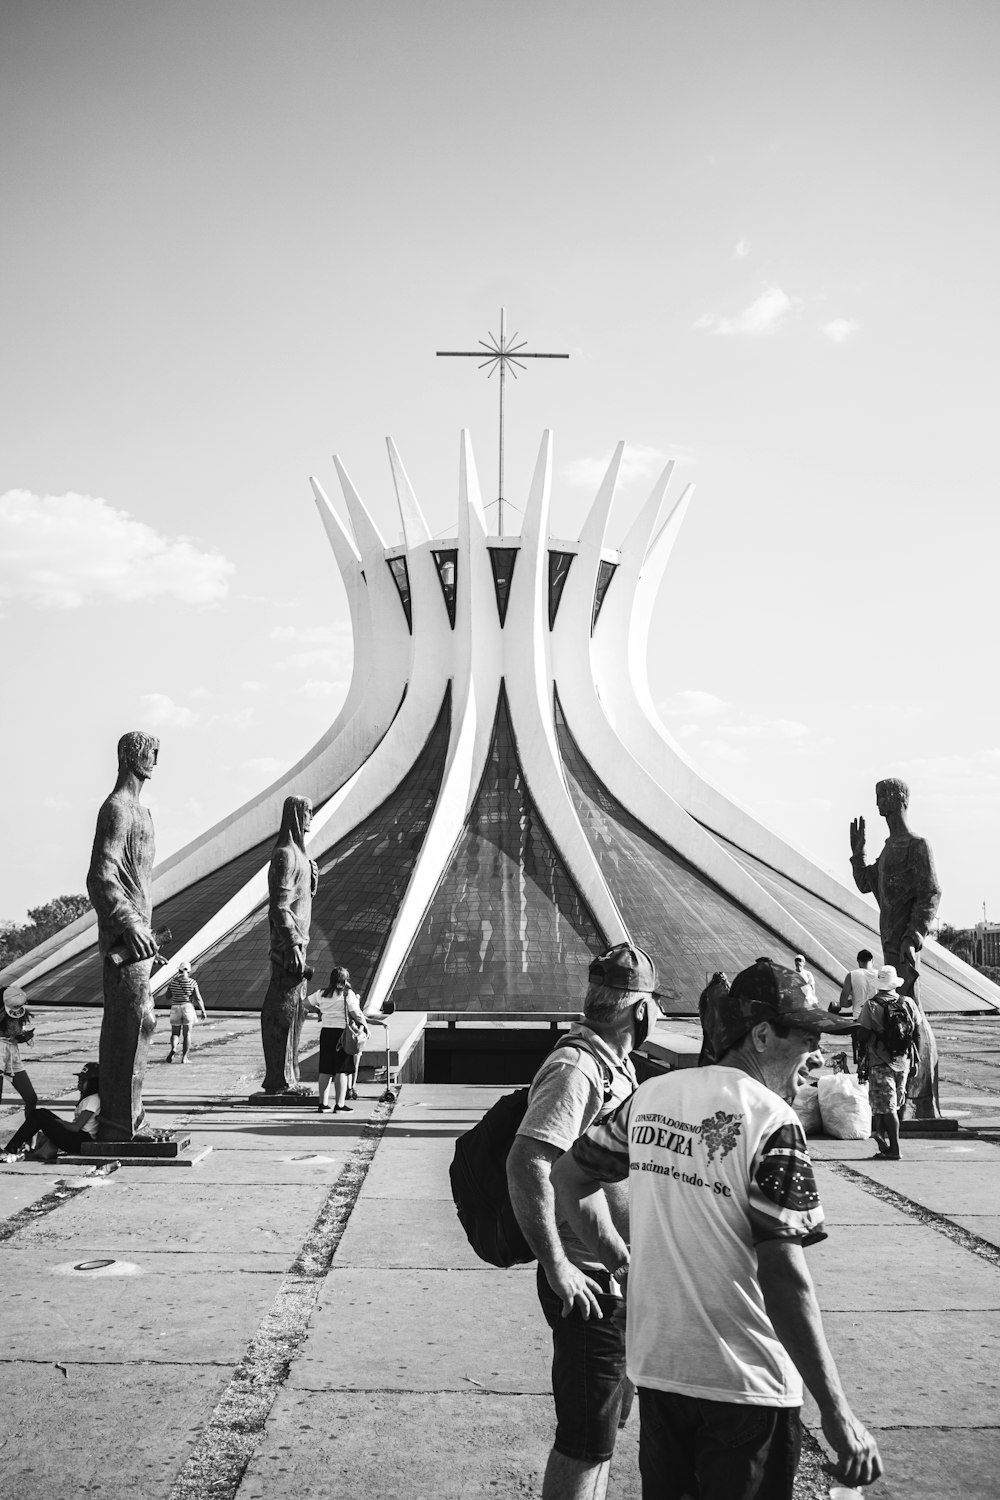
<box><xmin>0</xmin><ymin>0</ymin><xmax>1000</xmax><ymax>924</ymax></box>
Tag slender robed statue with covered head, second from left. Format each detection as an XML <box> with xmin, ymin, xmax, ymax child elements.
<box><xmin>261</xmin><ymin>797</ymin><xmax>319</xmax><ymax>1094</ymax></box>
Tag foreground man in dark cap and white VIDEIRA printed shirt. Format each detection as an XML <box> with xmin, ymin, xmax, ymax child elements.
<box><xmin>552</xmin><ymin>963</ymin><xmax>882</xmax><ymax>1500</ymax></box>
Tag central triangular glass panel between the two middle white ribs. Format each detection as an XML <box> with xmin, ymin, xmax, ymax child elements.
<box><xmin>393</xmin><ymin>687</ymin><xmax>604</xmax><ymax>1011</ymax></box>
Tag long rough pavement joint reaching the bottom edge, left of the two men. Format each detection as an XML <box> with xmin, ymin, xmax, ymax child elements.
<box><xmin>169</xmin><ymin>1100</ymin><xmax>396</xmax><ymax>1500</ymax></box>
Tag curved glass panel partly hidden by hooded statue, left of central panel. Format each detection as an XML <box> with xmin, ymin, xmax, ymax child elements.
<box><xmin>195</xmin><ymin>687</ymin><xmax>451</xmax><ymax>1010</ymax></box>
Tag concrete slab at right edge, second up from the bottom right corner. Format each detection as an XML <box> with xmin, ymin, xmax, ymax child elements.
<box><xmin>802</xmin><ymin>1314</ymin><xmax>1000</xmax><ymax>1428</ymax></box>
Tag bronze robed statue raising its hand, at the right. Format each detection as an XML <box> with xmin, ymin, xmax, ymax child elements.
<box><xmin>850</xmin><ymin>776</ymin><xmax>942</xmax><ymax>1121</ymax></box>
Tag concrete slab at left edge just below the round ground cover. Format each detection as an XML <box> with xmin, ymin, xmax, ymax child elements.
<box><xmin>3</xmin><ymin>1248</ymin><xmax>279</xmax><ymax>1365</ymax></box>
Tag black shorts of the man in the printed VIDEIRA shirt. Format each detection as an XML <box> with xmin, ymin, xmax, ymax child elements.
<box><xmin>639</xmin><ymin>1386</ymin><xmax>802</xmax><ymax>1500</ymax></box>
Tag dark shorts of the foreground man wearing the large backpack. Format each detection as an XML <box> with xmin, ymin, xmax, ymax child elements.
<box><xmin>537</xmin><ymin>1266</ymin><xmax>636</xmax><ymax>1464</ymax></box>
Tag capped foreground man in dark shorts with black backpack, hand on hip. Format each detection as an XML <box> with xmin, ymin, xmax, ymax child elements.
<box><xmin>507</xmin><ymin>944</ymin><xmax>660</xmax><ymax>1500</ymax></box>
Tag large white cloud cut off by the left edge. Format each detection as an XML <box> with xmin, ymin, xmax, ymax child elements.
<box><xmin>0</xmin><ymin>489</ymin><xmax>235</xmax><ymax>609</ymax></box>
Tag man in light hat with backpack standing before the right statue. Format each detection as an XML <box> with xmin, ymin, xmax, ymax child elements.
<box><xmin>858</xmin><ymin>965</ymin><xmax>921</xmax><ymax>1161</ymax></box>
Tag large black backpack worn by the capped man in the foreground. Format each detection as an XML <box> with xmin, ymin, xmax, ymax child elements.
<box><xmin>448</xmin><ymin>1037</ymin><xmax>612</xmax><ymax>1269</ymax></box>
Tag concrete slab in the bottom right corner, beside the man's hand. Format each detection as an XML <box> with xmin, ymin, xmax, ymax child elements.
<box><xmin>873</xmin><ymin>1427</ymin><xmax>1000</xmax><ymax>1500</ymax></box>
